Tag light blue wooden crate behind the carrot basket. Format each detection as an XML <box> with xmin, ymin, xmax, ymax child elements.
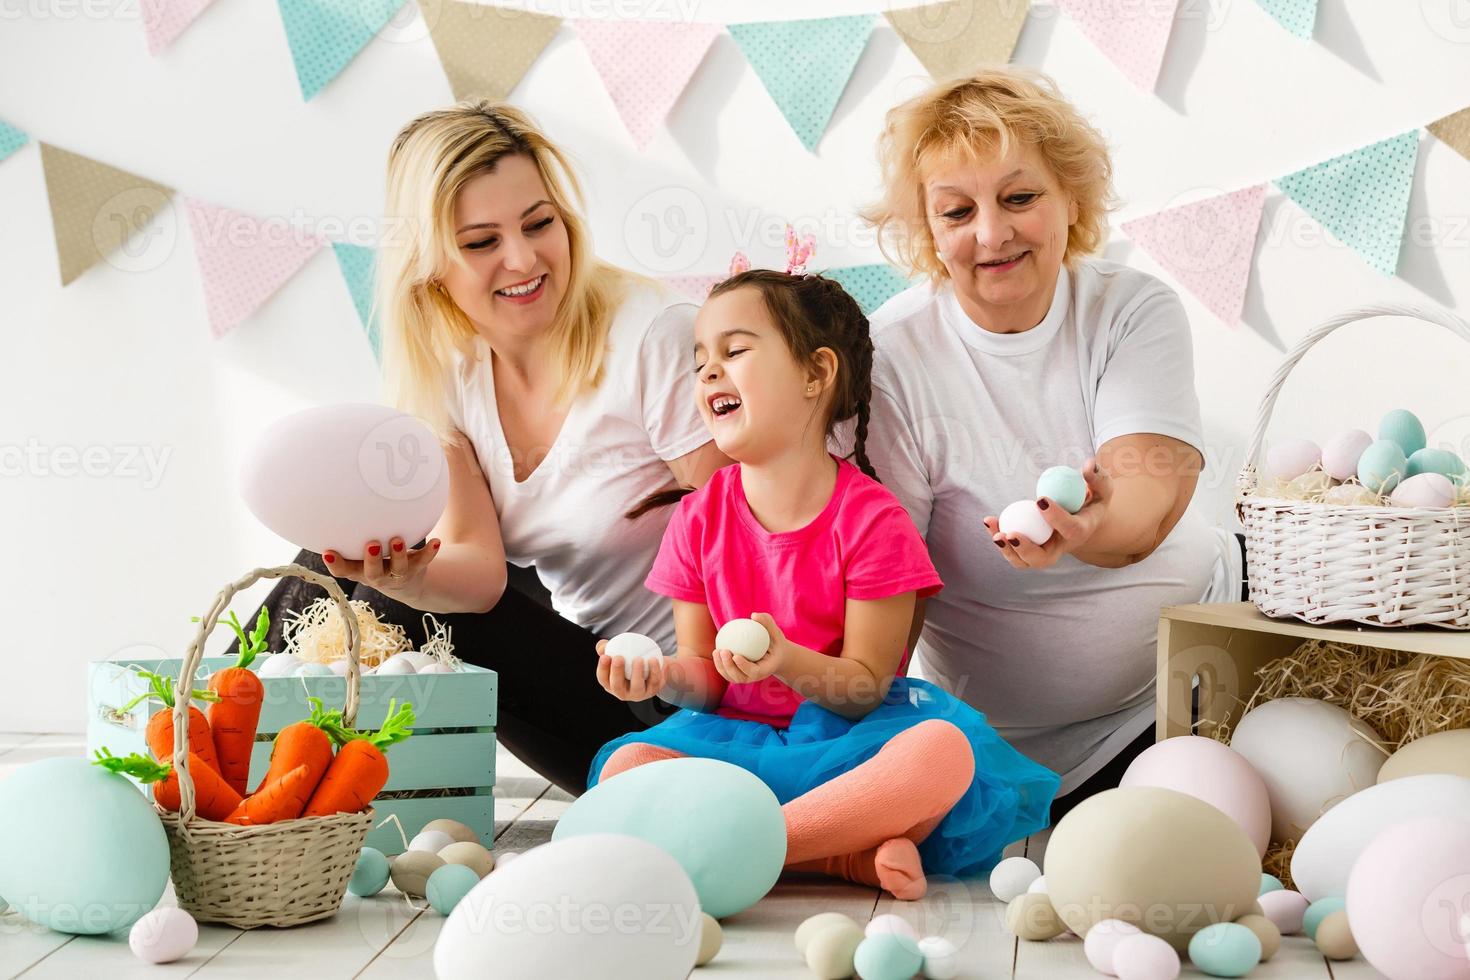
<box><xmin>87</xmin><ymin>657</ymin><xmax>497</xmax><ymax>855</ymax></box>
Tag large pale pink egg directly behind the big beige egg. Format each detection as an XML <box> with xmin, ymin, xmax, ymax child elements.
<box><xmin>1122</xmin><ymin>735</ymin><xmax>1272</xmax><ymax>855</ymax></box>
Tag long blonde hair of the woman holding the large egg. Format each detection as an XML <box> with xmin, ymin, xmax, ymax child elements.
<box><xmin>373</xmin><ymin>100</ymin><xmax>638</xmax><ymax>436</ymax></box>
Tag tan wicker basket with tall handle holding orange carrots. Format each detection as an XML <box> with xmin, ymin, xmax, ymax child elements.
<box><xmin>159</xmin><ymin>564</ymin><xmax>373</xmax><ymax>929</ymax></box>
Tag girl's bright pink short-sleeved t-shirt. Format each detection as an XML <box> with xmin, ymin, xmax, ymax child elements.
<box><xmin>645</xmin><ymin>457</ymin><xmax>944</xmax><ymax>729</ymax></box>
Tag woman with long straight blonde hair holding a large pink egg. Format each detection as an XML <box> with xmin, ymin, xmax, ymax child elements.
<box><xmin>241</xmin><ymin>101</ymin><xmax>728</xmax><ymax>793</ymax></box>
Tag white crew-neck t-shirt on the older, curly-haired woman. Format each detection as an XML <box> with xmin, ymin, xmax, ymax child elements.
<box><xmin>848</xmin><ymin>260</ymin><xmax>1239</xmax><ymax>793</ymax></box>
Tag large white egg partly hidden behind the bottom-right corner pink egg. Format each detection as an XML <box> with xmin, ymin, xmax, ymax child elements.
<box><xmin>1291</xmin><ymin>773</ymin><xmax>1470</xmax><ymax>902</ymax></box>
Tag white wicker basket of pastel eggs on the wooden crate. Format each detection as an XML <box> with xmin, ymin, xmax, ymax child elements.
<box><xmin>1236</xmin><ymin>303</ymin><xmax>1470</xmax><ymax>629</ymax></box>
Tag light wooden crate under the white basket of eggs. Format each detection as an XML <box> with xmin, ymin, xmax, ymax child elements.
<box><xmin>1154</xmin><ymin>602</ymin><xmax>1470</xmax><ymax>741</ymax></box>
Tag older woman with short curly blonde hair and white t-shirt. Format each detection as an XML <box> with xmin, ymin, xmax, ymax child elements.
<box><xmin>867</xmin><ymin>68</ymin><xmax>1241</xmax><ymax>818</ymax></box>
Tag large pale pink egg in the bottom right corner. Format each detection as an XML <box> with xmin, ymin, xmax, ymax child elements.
<box><xmin>1348</xmin><ymin>817</ymin><xmax>1470</xmax><ymax>980</ymax></box>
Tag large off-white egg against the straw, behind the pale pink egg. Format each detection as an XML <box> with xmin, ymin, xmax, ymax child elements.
<box><xmin>1230</xmin><ymin>698</ymin><xmax>1388</xmax><ymax>842</ymax></box>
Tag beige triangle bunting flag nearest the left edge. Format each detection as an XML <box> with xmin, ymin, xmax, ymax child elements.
<box><xmin>41</xmin><ymin>143</ymin><xmax>173</xmax><ymax>287</ymax></box>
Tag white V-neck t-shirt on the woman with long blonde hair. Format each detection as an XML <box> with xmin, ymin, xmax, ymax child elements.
<box><xmin>450</xmin><ymin>284</ymin><xmax>710</xmax><ymax>658</ymax></box>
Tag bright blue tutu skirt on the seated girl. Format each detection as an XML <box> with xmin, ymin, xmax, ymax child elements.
<box><xmin>587</xmin><ymin>677</ymin><xmax>1061</xmax><ymax>877</ymax></box>
